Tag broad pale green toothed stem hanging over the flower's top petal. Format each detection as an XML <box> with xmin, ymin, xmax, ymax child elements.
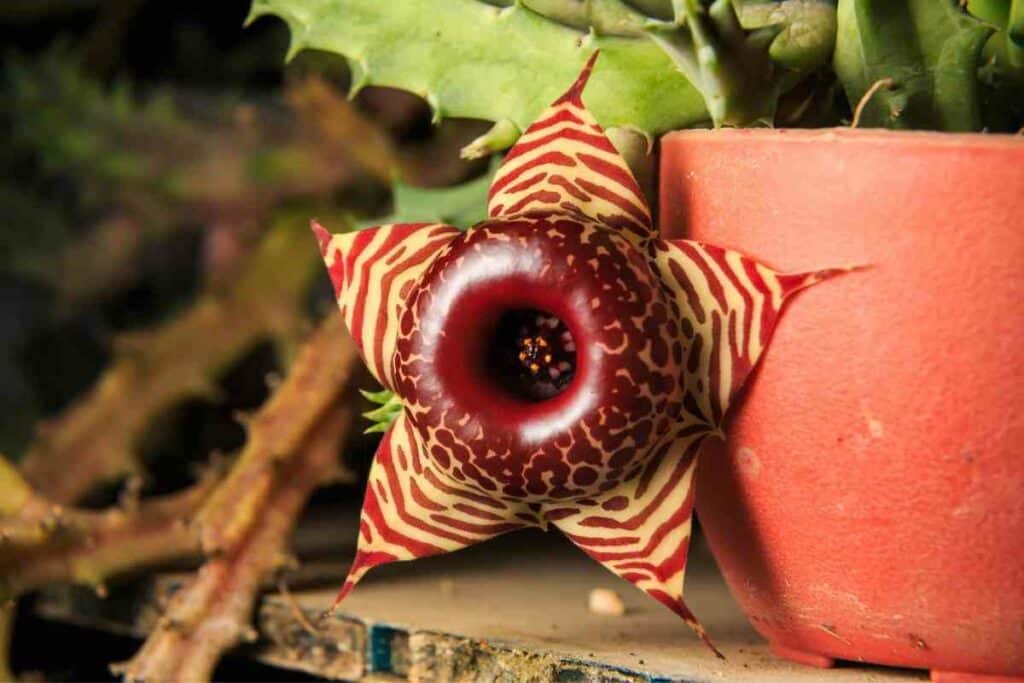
<box><xmin>249</xmin><ymin>0</ymin><xmax>708</xmax><ymax>135</ymax></box>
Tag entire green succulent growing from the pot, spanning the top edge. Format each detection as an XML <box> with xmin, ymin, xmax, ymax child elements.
<box><xmin>250</xmin><ymin>0</ymin><xmax>1024</xmax><ymax>141</ymax></box>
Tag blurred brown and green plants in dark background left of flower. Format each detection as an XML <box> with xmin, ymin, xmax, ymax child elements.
<box><xmin>0</xmin><ymin>0</ymin><xmax>487</xmax><ymax>680</ymax></box>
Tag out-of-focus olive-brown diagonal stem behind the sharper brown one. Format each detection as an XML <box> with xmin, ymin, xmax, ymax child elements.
<box><xmin>22</xmin><ymin>217</ymin><xmax>318</xmax><ymax>503</ymax></box>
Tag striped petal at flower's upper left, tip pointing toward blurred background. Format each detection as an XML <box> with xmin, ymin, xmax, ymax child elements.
<box><xmin>312</xmin><ymin>221</ymin><xmax>460</xmax><ymax>391</ymax></box>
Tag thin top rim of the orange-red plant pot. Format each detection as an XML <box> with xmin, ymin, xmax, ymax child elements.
<box><xmin>662</xmin><ymin>127</ymin><xmax>1024</xmax><ymax>153</ymax></box>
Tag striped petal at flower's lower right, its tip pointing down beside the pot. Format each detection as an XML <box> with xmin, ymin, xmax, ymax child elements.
<box><xmin>543</xmin><ymin>428</ymin><xmax>721</xmax><ymax>656</ymax></box>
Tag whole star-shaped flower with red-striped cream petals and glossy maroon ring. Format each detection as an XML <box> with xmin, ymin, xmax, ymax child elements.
<box><xmin>313</xmin><ymin>53</ymin><xmax>836</xmax><ymax>645</ymax></box>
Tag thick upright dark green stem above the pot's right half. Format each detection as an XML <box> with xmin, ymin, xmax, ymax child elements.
<box><xmin>835</xmin><ymin>0</ymin><xmax>992</xmax><ymax>131</ymax></box>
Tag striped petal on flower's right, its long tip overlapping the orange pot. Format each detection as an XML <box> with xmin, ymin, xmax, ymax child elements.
<box><xmin>654</xmin><ymin>240</ymin><xmax>847</xmax><ymax>430</ymax></box>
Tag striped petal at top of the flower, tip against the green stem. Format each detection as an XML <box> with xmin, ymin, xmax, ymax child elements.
<box><xmin>487</xmin><ymin>52</ymin><xmax>654</xmax><ymax>241</ymax></box>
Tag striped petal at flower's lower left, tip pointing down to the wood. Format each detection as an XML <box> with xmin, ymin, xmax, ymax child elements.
<box><xmin>332</xmin><ymin>414</ymin><xmax>540</xmax><ymax>609</ymax></box>
